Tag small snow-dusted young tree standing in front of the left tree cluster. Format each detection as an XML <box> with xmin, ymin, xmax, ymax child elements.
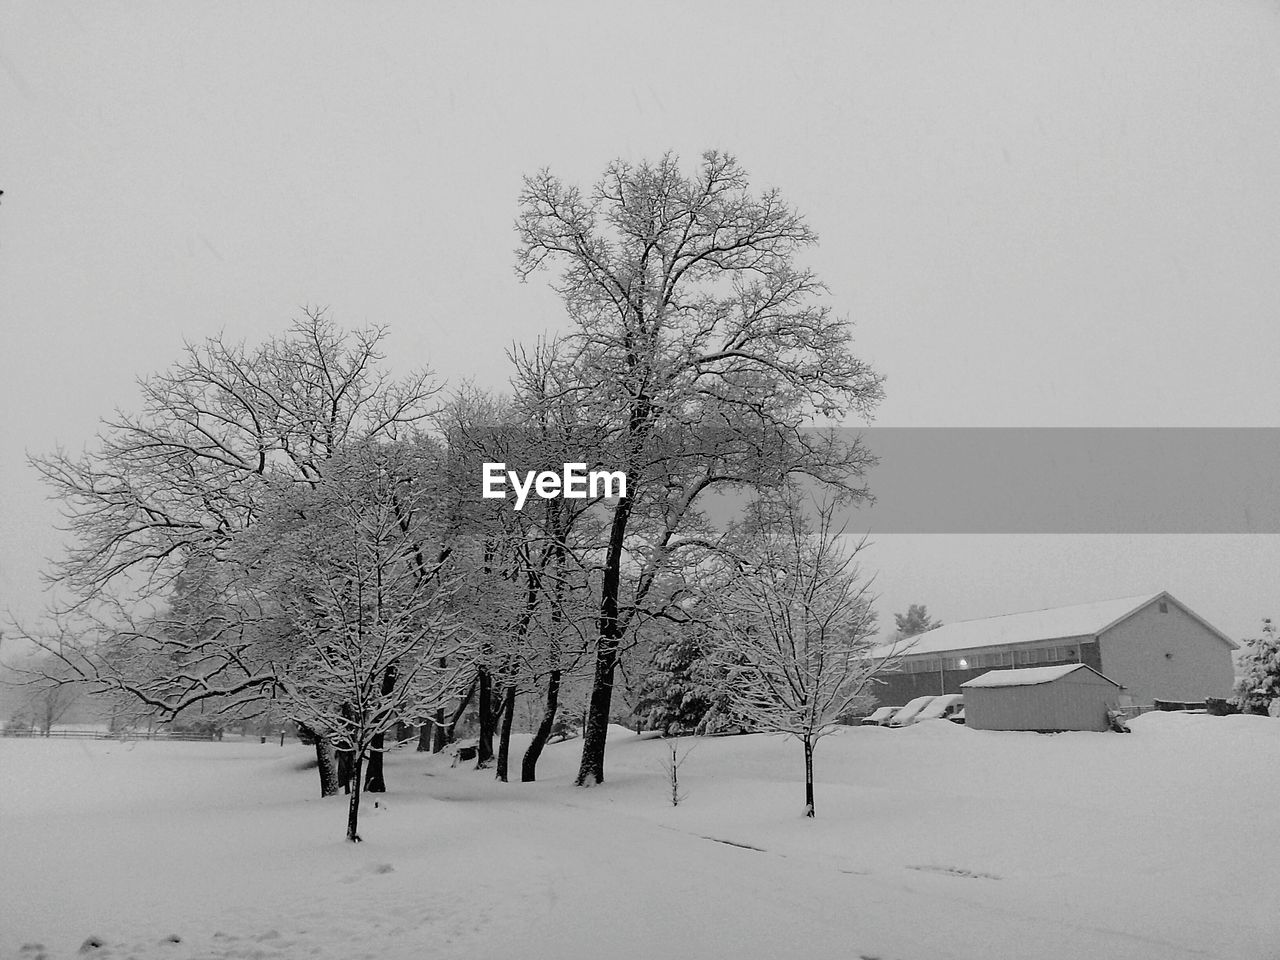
<box><xmin>238</xmin><ymin>443</ymin><xmax>471</xmax><ymax>841</ymax></box>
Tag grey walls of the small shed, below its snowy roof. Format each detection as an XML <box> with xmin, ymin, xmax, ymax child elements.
<box><xmin>964</xmin><ymin>669</ymin><xmax>1120</xmax><ymax>731</ymax></box>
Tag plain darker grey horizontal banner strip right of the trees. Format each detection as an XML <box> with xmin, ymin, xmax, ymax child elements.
<box><xmin>844</xmin><ymin>428</ymin><xmax>1280</xmax><ymax>534</ymax></box>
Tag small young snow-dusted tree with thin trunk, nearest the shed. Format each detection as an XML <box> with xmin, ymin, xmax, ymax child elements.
<box><xmin>710</xmin><ymin>498</ymin><xmax>892</xmax><ymax>817</ymax></box>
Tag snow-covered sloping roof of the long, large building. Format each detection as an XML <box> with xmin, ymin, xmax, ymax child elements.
<box><xmin>877</xmin><ymin>591</ymin><xmax>1167</xmax><ymax>657</ymax></box>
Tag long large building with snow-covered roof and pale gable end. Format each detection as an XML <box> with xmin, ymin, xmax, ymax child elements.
<box><xmin>876</xmin><ymin>591</ymin><xmax>1236</xmax><ymax>705</ymax></box>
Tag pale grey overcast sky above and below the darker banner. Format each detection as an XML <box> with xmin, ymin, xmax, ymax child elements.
<box><xmin>0</xmin><ymin>0</ymin><xmax>1280</xmax><ymax>647</ymax></box>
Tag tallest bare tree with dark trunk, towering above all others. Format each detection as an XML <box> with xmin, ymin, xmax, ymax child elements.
<box><xmin>517</xmin><ymin>151</ymin><xmax>881</xmax><ymax>785</ymax></box>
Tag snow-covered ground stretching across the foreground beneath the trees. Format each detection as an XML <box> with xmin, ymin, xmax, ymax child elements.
<box><xmin>0</xmin><ymin>714</ymin><xmax>1280</xmax><ymax>960</ymax></box>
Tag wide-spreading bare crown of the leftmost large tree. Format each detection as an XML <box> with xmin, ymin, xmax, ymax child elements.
<box><xmin>18</xmin><ymin>316</ymin><xmax>436</xmax><ymax>717</ymax></box>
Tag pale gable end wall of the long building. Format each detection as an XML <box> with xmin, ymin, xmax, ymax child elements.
<box><xmin>1097</xmin><ymin>602</ymin><xmax>1235</xmax><ymax>704</ymax></box>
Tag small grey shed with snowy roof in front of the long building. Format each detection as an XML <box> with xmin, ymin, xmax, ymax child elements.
<box><xmin>961</xmin><ymin>663</ymin><xmax>1120</xmax><ymax>733</ymax></box>
